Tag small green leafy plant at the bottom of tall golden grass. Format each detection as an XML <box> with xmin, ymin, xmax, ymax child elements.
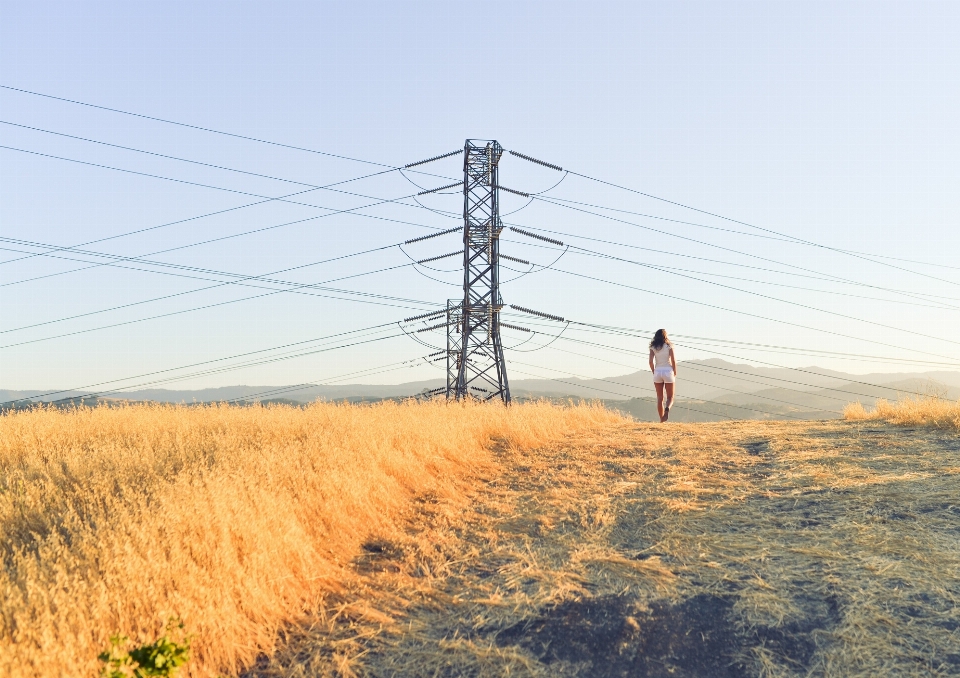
<box><xmin>98</xmin><ymin>618</ymin><xmax>190</xmax><ymax>678</ymax></box>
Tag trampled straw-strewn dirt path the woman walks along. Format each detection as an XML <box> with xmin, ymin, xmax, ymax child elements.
<box><xmin>249</xmin><ymin>422</ymin><xmax>960</xmax><ymax>678</ymax></box>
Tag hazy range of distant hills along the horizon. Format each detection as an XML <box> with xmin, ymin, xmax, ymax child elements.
<box><xmin>0</xmin><ymin>358</ymin><xmax>960</xmax><ymax>421</ymax></box>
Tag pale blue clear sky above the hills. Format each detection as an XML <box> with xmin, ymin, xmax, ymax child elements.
<box><xmin>0</xmin><ymin>0</ymin><xmax>960</xmax><ymax>390</ymax></box>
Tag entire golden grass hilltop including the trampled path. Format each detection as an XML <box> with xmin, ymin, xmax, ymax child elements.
<box><xmin>0</xmin><ymin>400</ymin><xmax>960</xmax><ymax>678</ymax></box>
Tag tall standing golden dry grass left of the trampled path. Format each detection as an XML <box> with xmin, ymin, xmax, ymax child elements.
<box><xmin>0</xmin><ymin>403</ymin><xmax>624</xmax><ymax>677</ymax></box>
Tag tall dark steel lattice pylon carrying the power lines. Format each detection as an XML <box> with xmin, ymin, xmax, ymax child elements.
<box><xmin>456</xmin><ymin>139</ymin><xmax>510</xmax><ymax>403</ymax></box>
